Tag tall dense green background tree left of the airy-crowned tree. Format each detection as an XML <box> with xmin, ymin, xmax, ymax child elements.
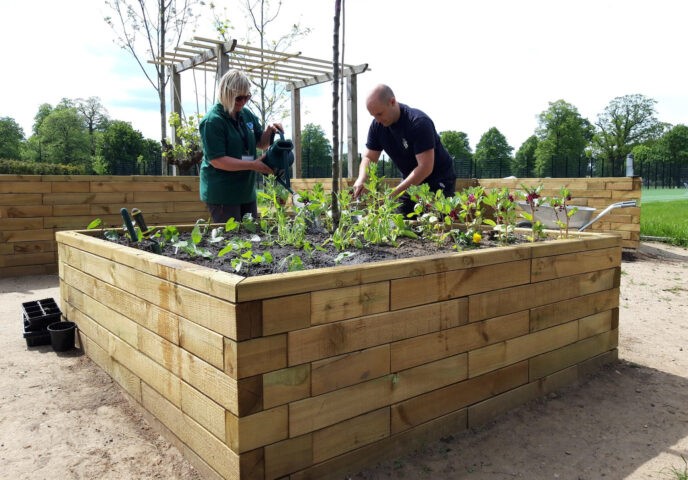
<box><xmin>535</xmin><ymin>100</ymin><xmax>593</xmax><ymax>177</ymax></box>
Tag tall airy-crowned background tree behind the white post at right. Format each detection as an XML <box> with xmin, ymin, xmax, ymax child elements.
<box><xmin>593</xmin><ymin>94</ymin><xmax>666</xmax><ymax>175</ymax></box>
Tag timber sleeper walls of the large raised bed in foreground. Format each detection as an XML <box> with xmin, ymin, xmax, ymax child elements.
<box><xmin>57</xmin><ymin>225</ymin><xmax>621</xmax><ymax>479</ymax></box>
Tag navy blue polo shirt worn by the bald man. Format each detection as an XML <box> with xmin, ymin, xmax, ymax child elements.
<box><xmin>366</xmin><ymin>103</ymin><xmax>456</xmax><ymax>190</ymax></box>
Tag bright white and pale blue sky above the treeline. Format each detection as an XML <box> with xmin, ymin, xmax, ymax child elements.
<box><xmin>0</xmin><ymin>0</ymin><xmax>688</xmax><ymax>149</ymax></box>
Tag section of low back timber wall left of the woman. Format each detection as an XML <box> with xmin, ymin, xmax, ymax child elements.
<box><xmin>0</xmin><ymin>175</ymin><xmax>208</xmax><ymax>277</ymax></box>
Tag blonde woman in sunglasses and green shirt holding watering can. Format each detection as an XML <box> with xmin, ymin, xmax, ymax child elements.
<box><xmin>199</xmin><ymin>70</ymin><xmax>283</xmax><ymax>223</ymax></box>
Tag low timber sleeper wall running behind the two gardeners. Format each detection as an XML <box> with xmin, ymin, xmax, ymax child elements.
<box><xmin>0</xmin><ymin>175</ymin><xmax>641</xmax><ymax>277</ymax></box>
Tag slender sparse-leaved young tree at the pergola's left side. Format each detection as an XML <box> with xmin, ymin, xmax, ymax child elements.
<box><xmin>105</xmin><ymin>0</ymin><xmax>202</xmax><ymax>151</ymax></box>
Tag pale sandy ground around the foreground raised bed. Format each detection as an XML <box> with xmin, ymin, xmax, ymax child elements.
<box><xmin>0</xmin><ymin>243</ymin><xmax>688</xmax><ymax>480</ymax></box>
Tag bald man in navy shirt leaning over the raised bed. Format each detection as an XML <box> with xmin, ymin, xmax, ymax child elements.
<box><xmin>354</xmin><ymin>85</ymin><xmax>456</xmax><ymax>214</ymax></box>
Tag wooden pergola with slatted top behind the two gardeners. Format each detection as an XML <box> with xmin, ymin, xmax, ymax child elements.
<box><xmin>152</xmin><ymin>37</ymin><xmax>368</xmax><ymax>178</ymax></box>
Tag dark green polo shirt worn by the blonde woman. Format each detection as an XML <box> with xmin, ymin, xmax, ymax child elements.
<box><xmin>198</xmin><ymin>103</ymin><xmax>263</xmax><ymax>205</ymax></box>
